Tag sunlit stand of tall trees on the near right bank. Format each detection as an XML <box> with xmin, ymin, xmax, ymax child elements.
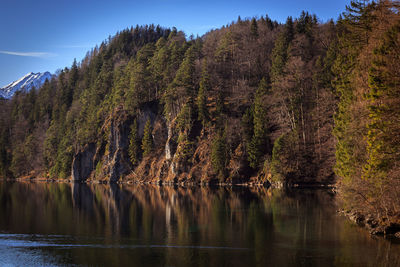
<box><xmin>333</xmin><ymin>1</ymin><xmax>400</xmax><ymax>228</ymax></box>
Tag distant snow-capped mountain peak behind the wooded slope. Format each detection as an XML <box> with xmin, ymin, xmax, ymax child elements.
<box><xmin>0</xmin><ymin>71</ymin><xmax>53</xmax><ymax>99</ymax></box>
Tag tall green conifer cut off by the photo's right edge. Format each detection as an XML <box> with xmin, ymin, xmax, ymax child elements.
<box><xmin>363</xmin><ymin>23</ymin><xmax>400</xmax><ymax>186</ymax></box>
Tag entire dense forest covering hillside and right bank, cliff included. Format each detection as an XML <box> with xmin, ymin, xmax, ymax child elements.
<box><xmin>0</xmin><ymin>0</ymin><xmax>400</xmax><ymax>226</ymax></box>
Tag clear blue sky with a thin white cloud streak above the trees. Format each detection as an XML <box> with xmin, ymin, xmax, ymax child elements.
<box><xmin>0</xmin><ymin>0</ymin><xmax>350</xmax><ymax>87</ymax></box>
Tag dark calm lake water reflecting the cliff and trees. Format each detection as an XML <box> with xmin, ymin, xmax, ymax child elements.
<box><xmin>0</xmin><ymin>182</ymin><xmax>400</xmax><ymax>267</ymax></box>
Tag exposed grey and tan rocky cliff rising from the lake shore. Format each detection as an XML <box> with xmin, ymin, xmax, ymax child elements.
<box><xmin>71</xmin><ymin>102</ymin><xmax>266</xmax><ymax>183</ymax></box>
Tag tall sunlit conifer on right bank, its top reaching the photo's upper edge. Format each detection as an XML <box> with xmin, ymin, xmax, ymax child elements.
<box><xmin>332</xmin><ymin>1</ymin><xmax>372</xmax><ymax>184</ymax></box>
